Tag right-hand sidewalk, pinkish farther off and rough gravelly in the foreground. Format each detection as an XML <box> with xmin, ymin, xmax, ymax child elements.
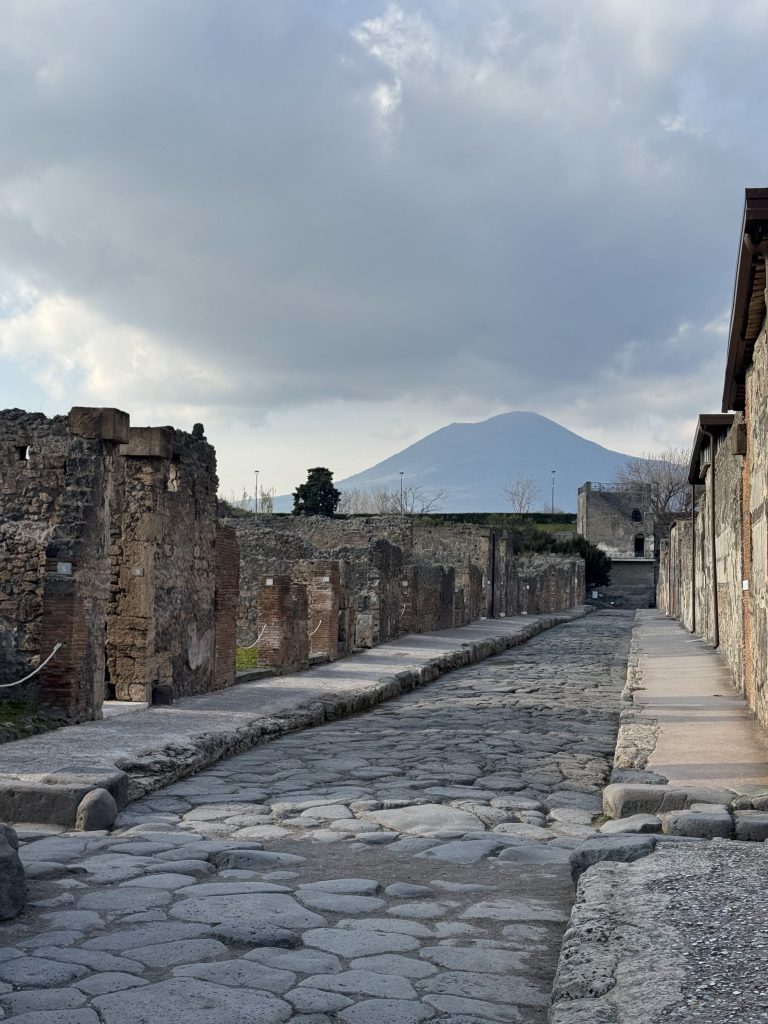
<box><xmin>550</xmin><ymin>610</ymin><xmax>768</xmax><ymax>1024</ymax></box>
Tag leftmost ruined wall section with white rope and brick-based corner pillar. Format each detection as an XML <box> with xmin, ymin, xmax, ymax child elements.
<box><xmin>0</xmin><ymin>409</ymin><xmax>128</xmax><ymax>721</ymax></box>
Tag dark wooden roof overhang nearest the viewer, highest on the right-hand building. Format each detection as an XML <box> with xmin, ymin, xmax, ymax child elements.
<box><xmin>723</xmin><ymin>188</ymin><xmax>768</xmax><ymax>413</ymax></box>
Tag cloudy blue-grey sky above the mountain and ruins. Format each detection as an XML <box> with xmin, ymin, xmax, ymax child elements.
<box><xmin>0</xmin><ymin>0</ymin><xmax>768</xmax><ymax>497</ymax></box>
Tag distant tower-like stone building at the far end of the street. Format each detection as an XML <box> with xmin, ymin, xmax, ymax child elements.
<box><xmin>577</xmin><ymin>481</ymin><xmax>658</xmax><ymax>608</ymax></box>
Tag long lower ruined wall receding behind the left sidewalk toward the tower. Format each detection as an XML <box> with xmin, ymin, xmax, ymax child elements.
<box><xmin>227</xmin><ymin>515</ymin><xmax>584</xmax><ymax>671</ymax></box>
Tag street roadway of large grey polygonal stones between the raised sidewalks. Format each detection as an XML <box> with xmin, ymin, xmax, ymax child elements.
<box><xmin>0</xmin><ymin>611</ymin><xmax>633</xmax><ymax>1024</ymax></box>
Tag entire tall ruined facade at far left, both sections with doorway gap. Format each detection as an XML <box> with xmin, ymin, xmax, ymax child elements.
<box><xmin>0</xmin><ymin>408</ymin><xmax>240</xmax><ymax>721</ymax></box>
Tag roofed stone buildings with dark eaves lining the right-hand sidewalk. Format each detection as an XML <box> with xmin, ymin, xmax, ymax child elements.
<box><xmin>657</xmin><ymin>188</ymin><xmax>768</xmax><ymax>726</ymax></box>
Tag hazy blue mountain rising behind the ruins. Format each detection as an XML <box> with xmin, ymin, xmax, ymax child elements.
<box><xmin>275</xmin><ymin>413</ymin><xmax>631</xmax><ymax>512</ymax></box>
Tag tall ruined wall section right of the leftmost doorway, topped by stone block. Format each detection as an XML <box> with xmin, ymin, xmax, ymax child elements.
<box><xmin>108</xmin><ymin>427</ymin><xmax>225</xmax><ymax>701</ymax></box>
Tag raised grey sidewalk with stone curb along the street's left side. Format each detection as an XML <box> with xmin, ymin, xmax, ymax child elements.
<box><xmin>0</xmin><ymin>607</ymin><xmax>589</xmax><ymax>826</ymax></box>
